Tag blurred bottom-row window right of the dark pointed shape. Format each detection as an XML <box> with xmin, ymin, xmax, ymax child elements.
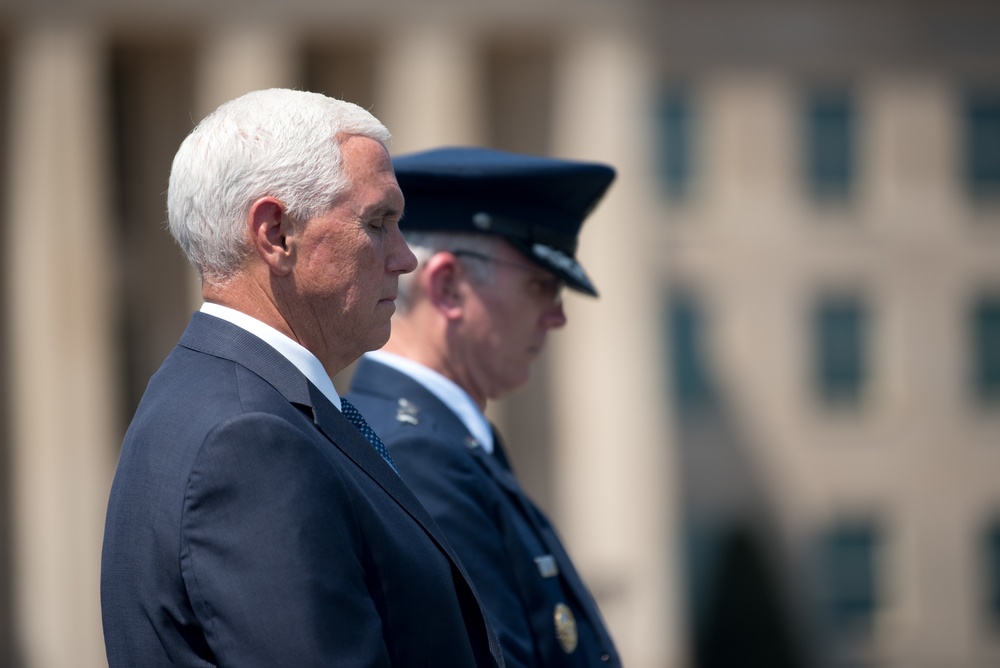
<box><xmin>819</xmin><ymin>522</ymin><xmax>879</xmax><ymax>632</ymax></box>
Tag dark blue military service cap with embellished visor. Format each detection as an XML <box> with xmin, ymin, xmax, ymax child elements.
<box><xmin>392</xmin><ymin>147</ymin><xmax>615</xmax><ymax>296</ymax></box>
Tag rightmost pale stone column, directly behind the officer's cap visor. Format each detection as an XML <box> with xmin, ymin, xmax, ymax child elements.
<box><xmin>549</xmin><ymin>30</ymin><xmax>686</xmax><ymax>668</ymax></box>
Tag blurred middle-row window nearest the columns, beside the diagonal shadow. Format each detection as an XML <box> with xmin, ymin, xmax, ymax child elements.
<box><xmin>667</xmin><ymin>294</ymin><xmax>712</xmax><ymax>409</ymax></box>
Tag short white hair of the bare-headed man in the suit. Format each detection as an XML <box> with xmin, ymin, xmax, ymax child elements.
<box><xmin>167</xmin><ymin>89</ymin><xmax>389</xmax><ymax>283</ymax></box>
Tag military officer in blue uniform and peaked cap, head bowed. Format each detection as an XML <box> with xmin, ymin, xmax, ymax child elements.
<box><xmin>347</xmin><ymin>147</ymin><xmax>620</xmax><ymax>667</ymax></box>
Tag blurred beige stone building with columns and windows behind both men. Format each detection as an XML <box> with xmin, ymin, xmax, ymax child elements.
<box><xmin>0</xmin><ymin>0</ymin><xmax>1000</xmax><ymax>668</ymax></box>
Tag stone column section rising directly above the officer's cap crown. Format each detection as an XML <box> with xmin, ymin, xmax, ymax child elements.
<box><xmin>373</xmin><ymin>24</ymin><xmax>485</xmax><ymax>155</ymax></box>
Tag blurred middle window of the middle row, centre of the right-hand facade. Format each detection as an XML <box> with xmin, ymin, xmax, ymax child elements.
<box><xmin>813</xmin><ymin>296</ymin><xmax>867</xmax><ymax>405</ymax></box>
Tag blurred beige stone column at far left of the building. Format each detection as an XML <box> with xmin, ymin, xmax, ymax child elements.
<box><xmin>4</xmin><ymin>26</ymin><xmax>121</xmax><ymax>668</ymax></box>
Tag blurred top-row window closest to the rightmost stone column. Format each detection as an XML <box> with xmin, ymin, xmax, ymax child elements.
<box><xmin>655</xmin><ymin>88</ymin><xmax>692</xmax><ymax>199</ymax></box>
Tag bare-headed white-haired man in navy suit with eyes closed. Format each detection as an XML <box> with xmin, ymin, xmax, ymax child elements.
<box><xmin>101</xmin><ymin>90</ymin><xmax>503</xmax><ymax>668</ymax></box>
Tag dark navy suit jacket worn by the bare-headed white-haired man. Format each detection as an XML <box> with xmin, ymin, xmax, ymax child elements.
<box><xmin>101</xmin><ymin>313</ymin><xmax>502</xmax><ymax>668</ymax></box>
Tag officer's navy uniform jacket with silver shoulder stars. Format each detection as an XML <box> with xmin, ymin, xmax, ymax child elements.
<box><xmin>346</xmin><ymin>358</ymin><xmax>621</xmax><ymax>668</ymax></box>
